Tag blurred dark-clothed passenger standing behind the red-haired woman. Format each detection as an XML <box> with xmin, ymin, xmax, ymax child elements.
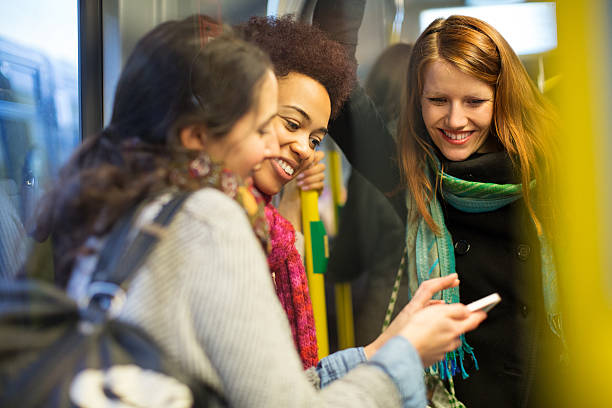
<box><xmin>327</xmin><ymin>43</ymin><xmax>412</xmax><ymax>344</ymax></box>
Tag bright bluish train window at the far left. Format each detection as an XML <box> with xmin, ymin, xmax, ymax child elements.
<box><xmin>0</xmin><ymin>0</ymin><xmax>80</xmax><ymax>276</ymax></box>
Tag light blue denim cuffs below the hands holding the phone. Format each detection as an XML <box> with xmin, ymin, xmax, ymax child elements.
<box><xmin>317</xmin><ymin>336</ymin><xmax>427</xmax><ymax>408</ymax></box>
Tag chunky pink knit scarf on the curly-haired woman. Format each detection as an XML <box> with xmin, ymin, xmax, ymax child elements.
<box><xmin>265</xmin><ymin>203</ymin><xmax>318</xmax><ymax>369</ymax></box>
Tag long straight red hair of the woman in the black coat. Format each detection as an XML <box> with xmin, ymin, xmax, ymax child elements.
<box><xmin>398</xmin><ymin>16</ymin><xmax>557</xmax><ymax>231</ymax></box>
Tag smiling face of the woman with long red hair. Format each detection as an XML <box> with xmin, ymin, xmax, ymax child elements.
<box><xmin>421</xmin><ymin>60</ymin><xmax>497</xmax><ymax>161</ymax></box>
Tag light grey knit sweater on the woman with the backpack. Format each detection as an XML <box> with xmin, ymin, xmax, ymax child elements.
<box><xmin>128</xmin><ymin>191</ymin><xmax>424</xmax><ymax>407</ymax></box>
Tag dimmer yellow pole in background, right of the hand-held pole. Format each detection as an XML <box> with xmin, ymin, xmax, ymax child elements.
<box><xmin>327</xmin><ymin>149</ymin><xmax>355</xmax><ymax>350</ymax></box>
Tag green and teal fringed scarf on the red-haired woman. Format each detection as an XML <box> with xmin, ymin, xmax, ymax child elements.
<box><xmin>404</xmin><ymin>156</ymin><xmax>563</xmax><ymax>383</ymax></box>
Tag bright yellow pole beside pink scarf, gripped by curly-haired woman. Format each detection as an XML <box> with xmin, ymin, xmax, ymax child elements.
<box><xmin>300</xmin><ymin>191</ymin><xmax>329</xmax><ymax>359</ymax></box>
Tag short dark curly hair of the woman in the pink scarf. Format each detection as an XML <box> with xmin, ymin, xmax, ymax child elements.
<box><xmin>236</xmin><ymin>15</ymin><xmax>357</xmax><ymax>118</ymax></box>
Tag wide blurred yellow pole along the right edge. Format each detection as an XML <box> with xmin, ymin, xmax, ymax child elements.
<box><xmin>549</xmin><ymin>0</ymin><xmax>612</xmax><ymax>407</ymax></box>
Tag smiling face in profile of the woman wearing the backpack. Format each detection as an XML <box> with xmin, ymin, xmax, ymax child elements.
<box><xmin>206</xmin><ymin>70</ymin><xmax>278</xmax><ymax>179</ymax></box>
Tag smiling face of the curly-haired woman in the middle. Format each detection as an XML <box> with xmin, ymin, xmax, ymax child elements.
<box><xmin>254</xmin><ymin>72</ymin><xmax>331</xmax><ymax>195</ymax></box>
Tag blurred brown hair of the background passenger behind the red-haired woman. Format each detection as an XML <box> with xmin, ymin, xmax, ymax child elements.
<box><xmin>364</xmin><ymin>43</ymin><xmax>412</xmax><ymax>122</ymax></box>
